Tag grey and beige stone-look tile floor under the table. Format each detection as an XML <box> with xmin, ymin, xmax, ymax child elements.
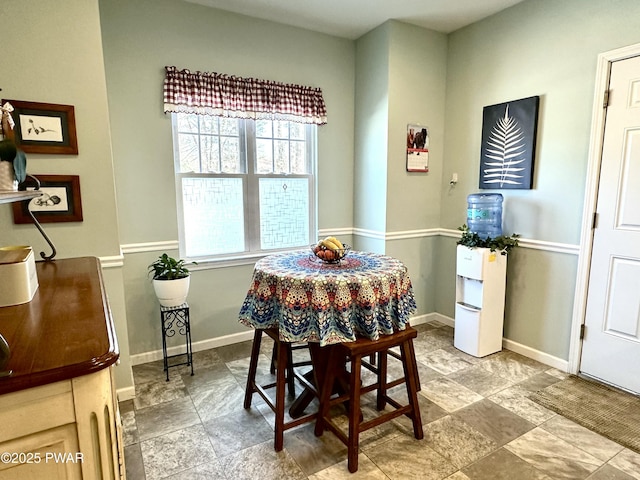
<box><xmin>120</xmin><ymin>322</ymin><xmax>640</xmax><ymax>480</ymax></box>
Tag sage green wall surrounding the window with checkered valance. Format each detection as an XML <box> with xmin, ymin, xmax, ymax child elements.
<box><xmin>100</xmin><ymin>0</ymin><xmax>355</xmax><ymax>354</ymax></box>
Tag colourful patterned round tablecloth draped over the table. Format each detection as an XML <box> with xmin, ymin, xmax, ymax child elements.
<box><xmin>239</xmin><ymin>250</ymin><xmax>416</xmax><ymax>346</ymax></box>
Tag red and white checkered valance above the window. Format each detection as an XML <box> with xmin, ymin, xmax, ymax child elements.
<box><xmin>164</xmin><ymin>67</ymin><xmax>327</xmax><ymax>125</ymax></box>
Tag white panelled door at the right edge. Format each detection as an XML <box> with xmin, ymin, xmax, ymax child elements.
<box><xmin>580</xmin><ymin>57</ymin><xmax>640</xmax><ymax>393</ymax></box>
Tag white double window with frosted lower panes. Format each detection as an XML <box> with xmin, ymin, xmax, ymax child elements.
<box><xmin>172</xmin><ymin>113</ymin><xmax>317</xmax><ymax>259</ymax></box>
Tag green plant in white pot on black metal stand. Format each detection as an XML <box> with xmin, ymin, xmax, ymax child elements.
<box><xmin>148</xmin><ymin>253</ymin><xmax>191</xmax><ymax>307</ymax></box>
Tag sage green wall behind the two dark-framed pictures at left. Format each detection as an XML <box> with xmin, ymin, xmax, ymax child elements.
<box><xmin>0</xmin><ymin>0</ymin><xmax>133</xmax><ymax>388</ymax></box>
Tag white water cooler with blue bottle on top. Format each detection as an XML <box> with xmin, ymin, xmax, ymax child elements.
<box><xmin>453</xmin><ymin>194</ymin><xmax>507</xmax><ymax>357</ymax></box>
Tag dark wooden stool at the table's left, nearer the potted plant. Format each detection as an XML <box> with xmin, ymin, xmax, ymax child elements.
<box><xmin>244</xmin><ymin>328</ymin><xmax>318</xmax><ymax>452</ymax></box>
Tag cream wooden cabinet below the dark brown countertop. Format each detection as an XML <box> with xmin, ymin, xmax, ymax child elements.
<box><xmin>0</xmin><ymin>367</ymin><xmax>124</xmax><ymax>480</ymax></box>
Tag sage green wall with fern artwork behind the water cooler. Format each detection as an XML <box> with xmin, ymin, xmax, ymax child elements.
<box><xmin>437</xmin><ymin>0</ymin><xmax>640</xmax><ymax>360</ymax></box>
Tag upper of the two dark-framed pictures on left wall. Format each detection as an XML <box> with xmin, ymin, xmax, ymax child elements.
<box><xmin>2</xmin><ymin>100</ymin><xmax>78</xmax><ymax>155</ymax></box>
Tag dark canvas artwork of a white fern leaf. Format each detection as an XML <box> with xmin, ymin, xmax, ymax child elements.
<box><xmin>479</xmin><ymin>96</ymin><xmax>540</xmax><ymax>189</ymax></box>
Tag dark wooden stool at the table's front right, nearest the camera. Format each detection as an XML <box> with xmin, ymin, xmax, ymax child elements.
<box><xmin>315</xmin><ymin>326</ymin><xmax>424</xmax><ymax>473</ymax></box>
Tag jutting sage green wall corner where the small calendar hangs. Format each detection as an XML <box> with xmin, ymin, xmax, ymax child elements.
<box><xmin>354</xmin><ymin>20</ymin><xmax>447</xmax><ymax>315</ymax></box>
